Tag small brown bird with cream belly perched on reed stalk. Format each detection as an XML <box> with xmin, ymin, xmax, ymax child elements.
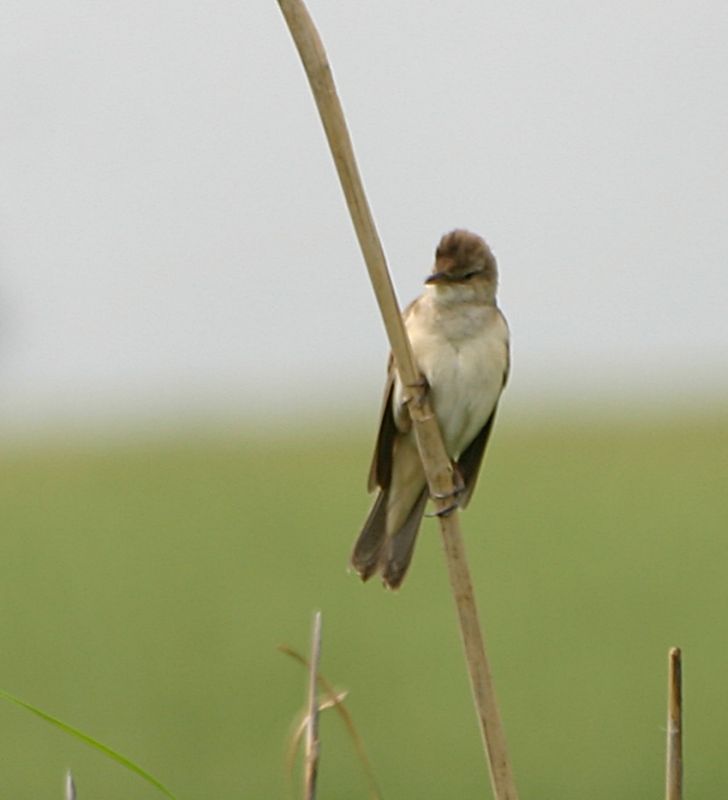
<box><xmin>351</xmin><ymin>229</ymin><xmax>510</xmax><ymax>589</ymax></box>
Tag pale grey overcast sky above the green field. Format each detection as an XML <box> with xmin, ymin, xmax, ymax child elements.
<box><xmin>0</xmin><ymin>0</ymin><xmax>728</xmax><ymax>438</ymax></box>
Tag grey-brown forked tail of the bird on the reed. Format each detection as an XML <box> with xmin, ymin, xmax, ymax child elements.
<box><xmin>351</xmin><ymin>488</ymin><xmax>427</xmax><ymax>589</ymax></box>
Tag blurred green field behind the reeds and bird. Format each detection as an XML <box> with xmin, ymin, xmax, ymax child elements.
<box><xmin>0</xmin><ymin>415</ymin><xmax>728</xmax><ymax>800</ymax></box>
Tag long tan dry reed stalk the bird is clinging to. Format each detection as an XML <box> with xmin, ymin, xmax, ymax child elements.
<box><xmin>278</xmin><ymin>0</ymin><xmax>518</xmax><ymax>800</ymax></box>
